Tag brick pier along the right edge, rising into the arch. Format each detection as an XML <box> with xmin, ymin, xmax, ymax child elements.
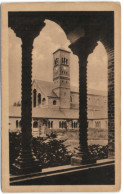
<box><xmin>100</xmin><ymin>34</ymin><xmax>115</xmax><ymax>158</ymax></box>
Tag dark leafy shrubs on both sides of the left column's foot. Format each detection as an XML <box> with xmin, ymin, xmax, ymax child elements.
<box><xmin>9</xmin><ymin>132</ymin><xmax>71</xmax><ymax>168</ymax></box>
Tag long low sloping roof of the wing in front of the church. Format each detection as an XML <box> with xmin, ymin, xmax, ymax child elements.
<box><xmin>9</xmin><ymin>106</ymin><xmax>107</xmax><ymax>119</ymax></box>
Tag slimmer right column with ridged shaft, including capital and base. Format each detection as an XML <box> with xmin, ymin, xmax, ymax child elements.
<box><xmin>70</xmin><ymin>38</ymin><xmax>97</xmax><ymax>165</ymax></box>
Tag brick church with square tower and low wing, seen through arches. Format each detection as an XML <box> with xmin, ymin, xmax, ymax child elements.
<box><xmin>9</xmin><ymin>49</ymin><xmax>108</xmax><ymax>136</ymax></box>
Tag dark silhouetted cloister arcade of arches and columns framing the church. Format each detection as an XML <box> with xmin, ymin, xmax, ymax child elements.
<box><xmin>8</xmin><ymin>11</ymin><xmax>115</xmax><ymax>174</ymax></box>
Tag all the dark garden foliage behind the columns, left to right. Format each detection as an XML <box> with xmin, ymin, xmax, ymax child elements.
<box><xmin>9</xmin><ymin>132</ymin><xmax>108</xmax><ymax>171</ymax></box>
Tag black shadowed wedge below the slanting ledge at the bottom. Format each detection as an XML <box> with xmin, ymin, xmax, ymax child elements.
<box><xmin>10</xmin><ymin>164</ymin><xmax>115</xmax><ymax>185</ymax></box>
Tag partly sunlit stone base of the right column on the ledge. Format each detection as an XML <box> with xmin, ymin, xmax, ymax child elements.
<box><xmin>71</xmin><ymin>154</ymin><xmax>96</xmax><ymax>166</ymax></box>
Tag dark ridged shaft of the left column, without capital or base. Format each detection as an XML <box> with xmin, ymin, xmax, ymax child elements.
<box><xmin>21</xmin><ymin>39</ymin><xmax>33</xmax><ymax>150</ymax></box>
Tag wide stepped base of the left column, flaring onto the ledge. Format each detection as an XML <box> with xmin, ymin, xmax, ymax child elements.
<box><xmin>10</xmin><ymin>152</ymin><xmax>42</xmax><ymax>175</ymax></box>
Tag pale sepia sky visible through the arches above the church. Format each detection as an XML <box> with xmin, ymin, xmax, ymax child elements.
<box><xmin>9</xmin><ymin>20</ymin><xmax>107</xmax><ymax>105</ymax></box>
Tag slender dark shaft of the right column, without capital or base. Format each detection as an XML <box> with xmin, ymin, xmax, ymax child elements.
<box><xmin>79</xmin><ymin>56</ymin><xmax>88</xmax><ymax>157</ymax></box>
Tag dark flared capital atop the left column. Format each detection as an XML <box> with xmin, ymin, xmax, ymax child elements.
<box><xmin>8</xmin><ymin>12</ymin><xmax>45</xmax><ymax>41</ymax></box>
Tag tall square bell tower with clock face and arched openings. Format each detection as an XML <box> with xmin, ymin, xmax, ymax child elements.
<box><xmin>53</xmin><ymin>49</ymin><xmax>70</xmax><ymax>108</ymax></box>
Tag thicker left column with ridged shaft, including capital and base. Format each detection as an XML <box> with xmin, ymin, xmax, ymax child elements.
<box><xmin>9</xmin><ymin>13</ymin><xmax>45</xmax><ymax>174</ymax></box>
